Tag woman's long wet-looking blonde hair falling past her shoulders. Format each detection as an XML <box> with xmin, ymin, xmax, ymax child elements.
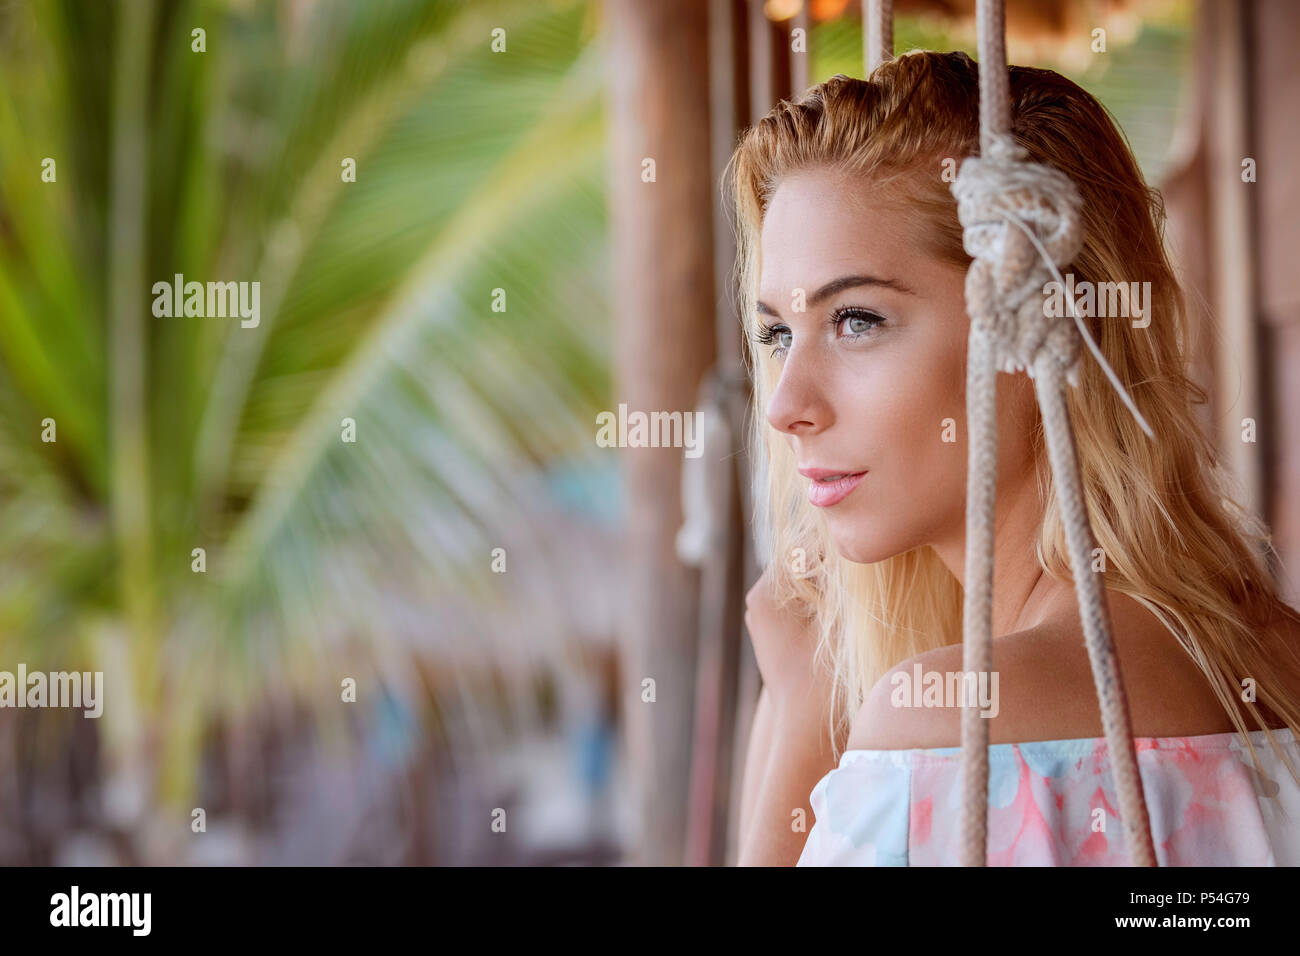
<box><xmin>723</xmin><ymin>52</ymin><xmax>1300</xmax><ymax>779</ymax></box>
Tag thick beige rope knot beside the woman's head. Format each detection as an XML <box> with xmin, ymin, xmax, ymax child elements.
<box><xmin>953</xmin><ymin>135</ymin><xmax>1083</xmax><ymax>385</ymax></box>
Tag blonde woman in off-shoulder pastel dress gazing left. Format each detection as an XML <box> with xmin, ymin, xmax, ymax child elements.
<box><xmin>725</xmin><ymin>52</ymin><xmax>1300</xmax><ymax>865</ymax></box>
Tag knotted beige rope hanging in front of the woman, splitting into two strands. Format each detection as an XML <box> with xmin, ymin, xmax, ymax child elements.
<box><xmin>953</xmin><ymin>0</ymin><xmax>1156</xmax><ymax>866</ymax></box>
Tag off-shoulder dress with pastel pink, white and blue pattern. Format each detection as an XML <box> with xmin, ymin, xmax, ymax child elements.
<box><xmin>798</xmin><ymin>730</ymin><xmax>1300</xmax><ymax>866</ymax></box>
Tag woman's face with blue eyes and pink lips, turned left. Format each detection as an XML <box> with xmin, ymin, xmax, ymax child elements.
<box><xmin>758</xmin><ymin>169</ymin><xmax>1035</xmax><ymax>563</ymax></box>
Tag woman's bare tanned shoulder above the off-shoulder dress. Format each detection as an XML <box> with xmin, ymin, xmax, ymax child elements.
<box><xmin>848</xmin><ymin>593</ymin><xmax>1232</xmax><ymax>750</ymax></box>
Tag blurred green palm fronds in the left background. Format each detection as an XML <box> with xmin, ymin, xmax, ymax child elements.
<box><xmin>0</xmin><ymin>0</ymin><xmax>608</xmax><ymax>806</ymax></box>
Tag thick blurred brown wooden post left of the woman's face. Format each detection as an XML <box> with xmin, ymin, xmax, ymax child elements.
<box><xmin>603</xmin><ymin>0</ymin><xmax>715</xmax><ymax>866</ymax></box>
